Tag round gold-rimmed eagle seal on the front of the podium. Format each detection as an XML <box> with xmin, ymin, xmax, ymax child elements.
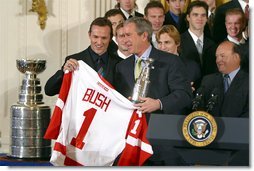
<box><xmin>182</xmin><ymin>111</ymin><xmax>217</xmax><ymax>147</ymax></box>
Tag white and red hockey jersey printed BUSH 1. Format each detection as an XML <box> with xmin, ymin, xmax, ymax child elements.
<box><xmin>44</xmin><ymin>61</ymin><xmax>153</xmax><ymax>166</ymax></box>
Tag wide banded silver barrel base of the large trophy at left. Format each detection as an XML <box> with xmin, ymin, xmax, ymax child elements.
<box><xmin>9</xmin><ymin>104</ymin><xmax>51</xmax><ymax>158</ymax></box>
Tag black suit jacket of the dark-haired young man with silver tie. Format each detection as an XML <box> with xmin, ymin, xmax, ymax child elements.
<box><xmin>180</xmin><ymin>30</ymin><xmax>217</xmax><ymax>76</ymax></box>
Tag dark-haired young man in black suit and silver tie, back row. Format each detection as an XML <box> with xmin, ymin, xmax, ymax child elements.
<box><xmin>180</xmin><ymin>1</ymin><xmax>217</xmax><ymax>87</ymax></box>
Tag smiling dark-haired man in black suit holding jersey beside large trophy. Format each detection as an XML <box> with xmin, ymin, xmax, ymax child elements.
<box><xmin>44</xmin><ymin>17</ymin><xmax>121</xmax><ymax>96</ymax></box>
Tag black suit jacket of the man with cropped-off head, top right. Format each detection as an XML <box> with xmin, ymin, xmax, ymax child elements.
<box><xmin>213</xmin><ymin>0</ymin><xmax>242</xmax><ymax>43</ymax></box>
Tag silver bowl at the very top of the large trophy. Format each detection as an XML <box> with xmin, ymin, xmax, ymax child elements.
<box><xmin>16</xmin><ymin>59</ymin><xmax>46</xmax><ymax>74</ymax></box>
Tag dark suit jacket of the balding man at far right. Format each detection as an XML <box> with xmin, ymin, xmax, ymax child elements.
<box><xmin>201</xmin><ymin>70</ymin><xmax>249</xmax><ymax>117</ymax></box>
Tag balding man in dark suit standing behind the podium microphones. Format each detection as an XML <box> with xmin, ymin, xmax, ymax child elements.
<box><xmin>201</xmin><ymin>41</ymin><xmax>249</xmax><ymax>117</ymax></box>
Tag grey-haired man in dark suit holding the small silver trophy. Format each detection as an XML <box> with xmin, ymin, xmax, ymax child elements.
<box><xmin>115</xmin><ymin>17</ymin><xmax>192</xmax><ymax>165</ymax></box>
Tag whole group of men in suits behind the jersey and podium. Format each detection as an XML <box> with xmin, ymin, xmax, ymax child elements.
<box><xmin>45</xmin><ymin>0</ymin><xmax>249</xmax><ymax>165</ymax></box>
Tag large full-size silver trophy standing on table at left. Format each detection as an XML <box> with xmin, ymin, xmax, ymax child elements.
<box><xmin>9</xmin><ymin>59</ymin><xmax>51</xmax><ymax>158</ymax></box>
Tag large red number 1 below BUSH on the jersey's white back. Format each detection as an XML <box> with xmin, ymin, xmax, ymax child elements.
<box><xmin>71</xmin><ymin>108</ymin><xmax>97</xmax><ymax>149</ymax></box>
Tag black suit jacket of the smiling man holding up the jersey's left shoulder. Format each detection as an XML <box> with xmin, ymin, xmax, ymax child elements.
<box><xmin>44</xmin><ymin>46</ymin><xmax>122</xmax><ymax>96</ymax></box>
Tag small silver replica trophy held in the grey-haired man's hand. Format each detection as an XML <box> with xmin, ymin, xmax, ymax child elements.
<box><xmin>131</xmin><ymin>58</ymin><xmax>154</xmax><ymax>103</ymax></box>
